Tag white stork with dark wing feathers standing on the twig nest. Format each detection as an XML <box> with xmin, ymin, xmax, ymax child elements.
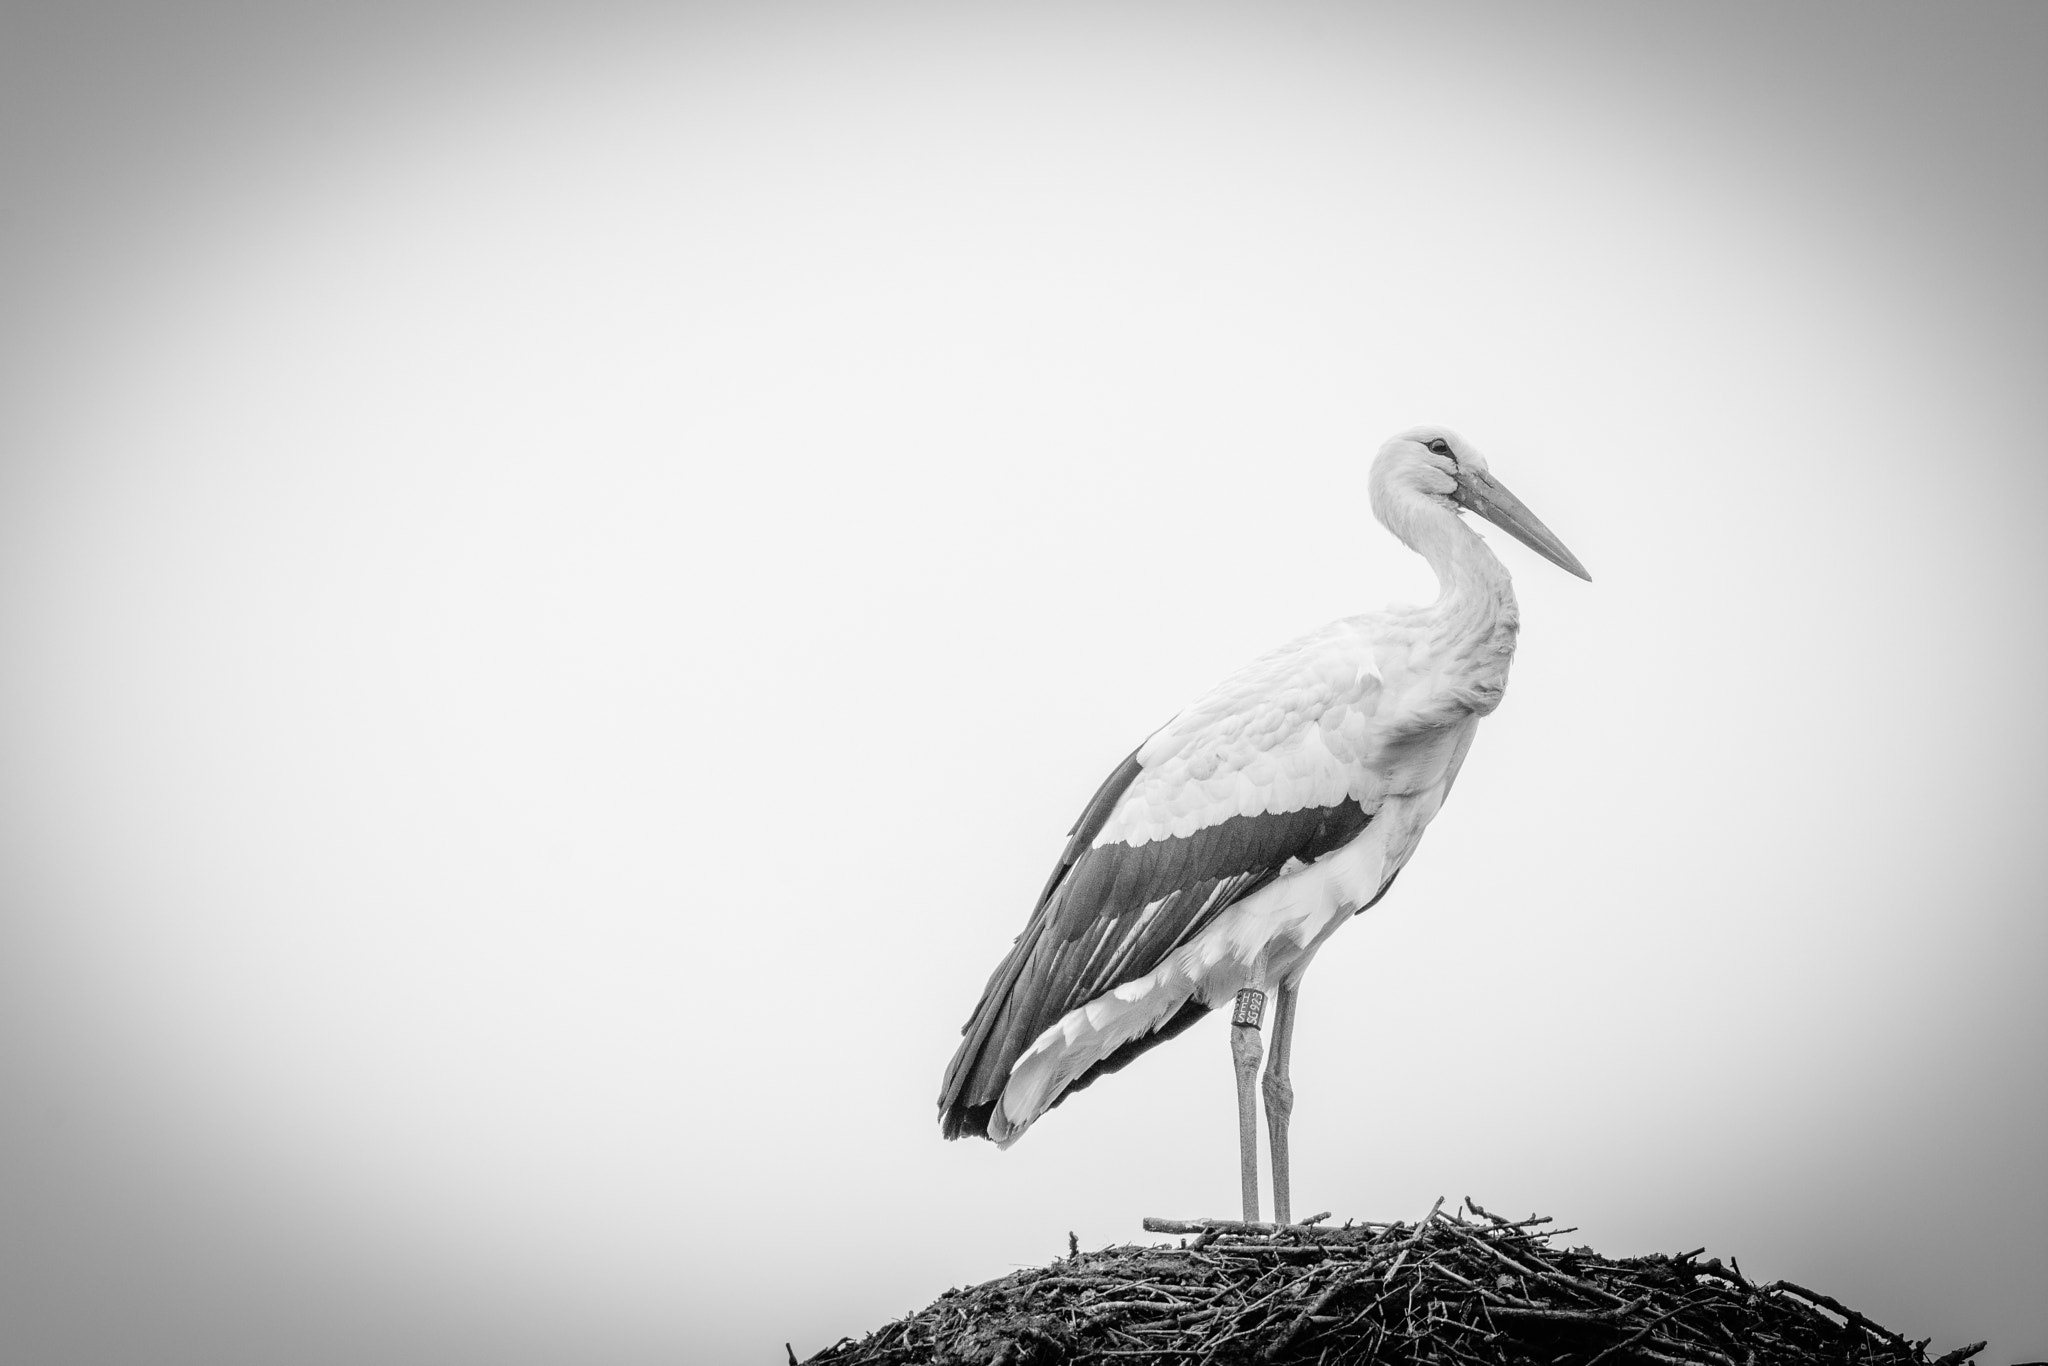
<box><xmin>938</xmin><ymin>426</ymin><xmax>1591</xmax><ymax>1223</ymax></box>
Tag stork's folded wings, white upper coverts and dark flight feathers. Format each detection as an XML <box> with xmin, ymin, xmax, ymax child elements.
<box><xmin>938</xmin><ymin>623</ymin><xmax>1380</xmax><ymax>1139</ymax></box>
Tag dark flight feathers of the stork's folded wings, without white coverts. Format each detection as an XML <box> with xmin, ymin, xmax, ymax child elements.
<box><xmin>938</xmin><ymin>754</ymin><xmax>1372</xmax><ymax>1139</ymax></box>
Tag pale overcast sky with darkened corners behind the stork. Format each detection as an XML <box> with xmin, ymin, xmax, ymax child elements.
<box><xmin>0</xmin><ymin>2</ymin><xmax>2048</xmax><ymax>1366</ymax></box>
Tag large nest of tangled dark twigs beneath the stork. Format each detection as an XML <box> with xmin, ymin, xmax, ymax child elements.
<box><xmin>791</xmin><ymin>1200</ymin><xmax>1985</xmax><ymax>1366</ymax></box>
